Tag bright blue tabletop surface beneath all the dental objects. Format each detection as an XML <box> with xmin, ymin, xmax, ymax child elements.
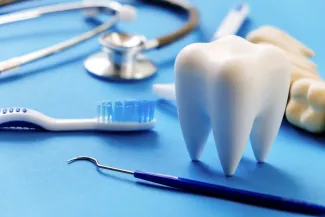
<box><xmin>0</xmin><ymin>0</ymin><xmax>325</xmax><ymax>217</ymax></box>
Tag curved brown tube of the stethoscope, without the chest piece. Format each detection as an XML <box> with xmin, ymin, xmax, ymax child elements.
<box><xmin>141</xmin><ymin>0</ymin><xmax>199</xmax><ymax>49</ymax></box>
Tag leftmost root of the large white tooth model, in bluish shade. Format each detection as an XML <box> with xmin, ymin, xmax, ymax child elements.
<box><xmin>175</xmin><ymin>48</ymin><xmax>211</xmax><ymax>161</ymax></box>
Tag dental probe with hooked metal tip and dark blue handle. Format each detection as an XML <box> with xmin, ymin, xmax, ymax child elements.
<box><xmin>67</xmin><ymin>156</ymin><xmax>325</xmax><ymax>216</ymax></box>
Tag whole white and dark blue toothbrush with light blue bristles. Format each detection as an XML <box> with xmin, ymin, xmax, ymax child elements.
<box><xmin>0</xmin><ymin>100</ymin><xmax>156</xmax><ymax>131</ymax></box>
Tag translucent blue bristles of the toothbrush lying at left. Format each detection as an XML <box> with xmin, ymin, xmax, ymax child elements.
<box><xmin>97</xmin><ymin>100</ymin><xmax>156</xmax><ymax>123</ymax></box>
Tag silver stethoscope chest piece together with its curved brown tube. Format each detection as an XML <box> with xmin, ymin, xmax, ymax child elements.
<box><xmin>84</xmin><ymin>0</ymin><xmax>199</xmax><ymax>80</ymax></box>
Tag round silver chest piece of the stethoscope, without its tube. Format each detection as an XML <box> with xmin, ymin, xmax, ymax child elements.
<box><xmin>84</xmin><ymin>32</ymin><xmax>157</xmax><ymax>80</ymax></box>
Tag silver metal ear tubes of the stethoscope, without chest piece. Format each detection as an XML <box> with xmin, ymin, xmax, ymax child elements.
<box><xmin>0</xmin><ymin>1</ymin><xmax>135</xmax><ymax>74</ymax></box>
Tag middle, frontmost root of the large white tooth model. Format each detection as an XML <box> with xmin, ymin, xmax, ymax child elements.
<box><xmin>209</xmin><ymin>71</ymin><xmax>254</xmax><ymax>176</ymax></box>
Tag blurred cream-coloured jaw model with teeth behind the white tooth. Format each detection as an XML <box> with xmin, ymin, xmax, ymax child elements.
<box><xmin>246</xmin><ymin>26</ymin><xmax>325</xmax><ymax>133</ymax></box>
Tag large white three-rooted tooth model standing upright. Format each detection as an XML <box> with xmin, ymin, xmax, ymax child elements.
<box><xmin>175</xmin><ymin>36</ymin><xmax>291</xmax><ymax>176</ymax></box>
